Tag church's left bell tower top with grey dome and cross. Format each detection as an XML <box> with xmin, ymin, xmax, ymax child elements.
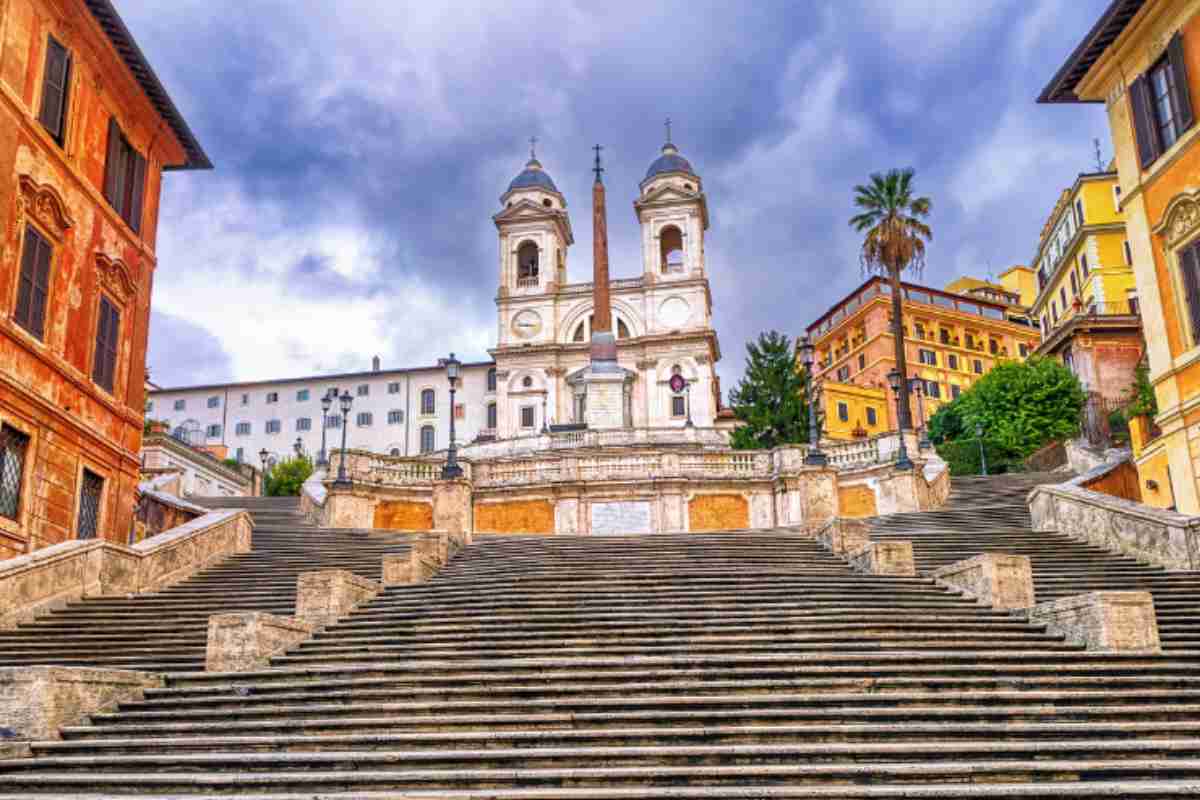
<box><xmin>492</xmin><ymin>139</ymin><xmax>575</xmax><ymax>296</ymax></box>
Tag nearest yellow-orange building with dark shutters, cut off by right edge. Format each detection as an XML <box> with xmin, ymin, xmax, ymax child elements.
<box><xmin>1038</xmin><ymin>0</ymin><xmax>1200</xmax><ymax>513</ymax></box>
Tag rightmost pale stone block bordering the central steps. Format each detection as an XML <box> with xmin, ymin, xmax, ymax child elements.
<box><xmin>1027</xmin><ymin>591</ymin><xmax>1160</xmax><ymax>652</ymax></box>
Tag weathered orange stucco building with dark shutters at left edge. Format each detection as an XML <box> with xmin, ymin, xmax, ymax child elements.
<box><xmin>0</xmin><ymin>0</ymin><xmax>211</xmax><ymax>559</ymax></box>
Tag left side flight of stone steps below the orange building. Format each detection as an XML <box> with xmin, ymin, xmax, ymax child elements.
<box><xmin>0</xmin><ymin>498</ymin><xmax>408</xmax><ymax>673</ymax></box>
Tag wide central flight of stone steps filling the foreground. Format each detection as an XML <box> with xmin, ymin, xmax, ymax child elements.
<box><xmin>0</xmin><ymin>522</ymin><xmax>1200</xmax><ymax>800</ymax></box>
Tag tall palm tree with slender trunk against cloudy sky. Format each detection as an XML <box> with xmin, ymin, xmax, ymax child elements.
<box><xmin>850</xmin><ymin>167</ymin><xmax>934</xmax><ymax>431</ymax></box>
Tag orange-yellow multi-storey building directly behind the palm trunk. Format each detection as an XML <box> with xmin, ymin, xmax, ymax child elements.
<box><xmin>808</xmin><ymin>277</ymin><xmax>1038</xmax><ymax>439</ymax></box>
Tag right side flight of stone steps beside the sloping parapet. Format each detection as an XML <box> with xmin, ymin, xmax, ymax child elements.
<box><xmin>871</xmin><ymin>473</ymin><xmax>1200</xmax><ymax>650</ymax></box>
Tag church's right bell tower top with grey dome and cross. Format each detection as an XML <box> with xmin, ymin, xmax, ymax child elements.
<box><xmin>634</xmin><ymin>120</ymin><xmax>708</xmax><ymax>283</ymax></box>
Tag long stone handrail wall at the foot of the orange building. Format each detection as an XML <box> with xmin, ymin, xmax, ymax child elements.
<box><xmin>0</xmin><ymin>509</ymin><xmax>253</xmax><ymax>630</ymax></box>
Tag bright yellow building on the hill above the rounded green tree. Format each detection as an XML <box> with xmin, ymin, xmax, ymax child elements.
<box><xmin>1030</xmin><ymin>172</ymin><xmax>1145</xmax><ymax>403</ymax></box>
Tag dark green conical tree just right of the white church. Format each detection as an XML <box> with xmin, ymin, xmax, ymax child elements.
<box><xmin>730</xmin><ymin>331</ymin><xmax>809</xmax><ymax>450</ymax></box>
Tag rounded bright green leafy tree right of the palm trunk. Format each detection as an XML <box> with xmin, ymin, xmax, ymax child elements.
<box><xmin>954</xmin><ymin>357</ymin><xmax>1087</xmax><ymax>458</ymax></box>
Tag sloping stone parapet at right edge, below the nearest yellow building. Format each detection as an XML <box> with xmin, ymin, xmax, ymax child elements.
<box><xmin>1030</xmin><ymin>474</ymin><xmax>1200</xmax><ymax>570</ymax></box>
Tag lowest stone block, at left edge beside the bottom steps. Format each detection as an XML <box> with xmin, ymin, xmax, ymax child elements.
<box><xmin>0</xmin><ymin>667</ymin><xmax>163</xmax><ymax>753</ymax></box>
